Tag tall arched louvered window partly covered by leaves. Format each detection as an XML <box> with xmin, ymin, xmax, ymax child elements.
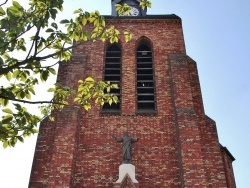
<box><xmin>102</xmin><ymin>44</ymin><xmax>121</xmax><ymax>113</ymax></box>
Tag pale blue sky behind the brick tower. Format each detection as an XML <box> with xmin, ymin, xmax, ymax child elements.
<box><xmin>0</xmin><ymin>0</ymin><xmax>250</xmax><ymax>188</ymax></box>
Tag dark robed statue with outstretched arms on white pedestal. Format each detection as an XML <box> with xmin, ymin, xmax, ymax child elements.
<box><xmin>113</xmin><ymin>131</ymin><xmax>139</xmax><ymax>164</ymax></box>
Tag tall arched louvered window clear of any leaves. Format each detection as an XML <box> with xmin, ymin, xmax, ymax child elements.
<box><xmin>137</xmin><ymin>44</ymin><xmax>155</xmax><ymax>113</ymax></box>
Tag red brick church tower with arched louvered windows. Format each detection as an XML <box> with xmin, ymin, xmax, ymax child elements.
<box><xmin>29</xmin><ymin>0</ymin><xmax>236</xmax><ymax>188</ymax></box>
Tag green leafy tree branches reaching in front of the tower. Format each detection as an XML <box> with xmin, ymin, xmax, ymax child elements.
<box><xmin>0</xmin><ymin>0</ymin><xmax>151</xmax><ymax>148</ymax></box>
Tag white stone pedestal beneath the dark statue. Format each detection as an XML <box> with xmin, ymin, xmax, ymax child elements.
<box><xmin>115</xmin><ymin>164</ymin><xmax>138</xmax><ymax>183</ymax></box>
